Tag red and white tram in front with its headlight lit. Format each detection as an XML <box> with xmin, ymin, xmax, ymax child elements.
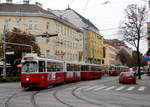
<box><xmin>21</xmin><ymin>54</ymin><xmax>101</xmax><ymax>88</ymax></box>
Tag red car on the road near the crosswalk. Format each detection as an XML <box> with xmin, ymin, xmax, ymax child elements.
<box><xmin>119</xmin><ymin>72</ymin><xmax>136</xmax><ymax>84</ymax></box>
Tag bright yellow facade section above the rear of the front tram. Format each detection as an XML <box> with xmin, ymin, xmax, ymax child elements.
<box><xmin>87</xmin><ymin>30</ymin><xmax>105</xmax><ymax>64</ymax></box>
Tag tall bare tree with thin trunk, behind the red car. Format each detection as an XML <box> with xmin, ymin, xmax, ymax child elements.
<box><xmin>120</xmin><ymin>4</ymin><xmax>146</xmax><ymax>79</ymax></box>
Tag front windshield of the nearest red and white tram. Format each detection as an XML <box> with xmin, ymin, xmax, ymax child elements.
<box><xmin>22</xmin><ymin>62</ymin><xmax>37</xmax><ymax>72</ymax></box>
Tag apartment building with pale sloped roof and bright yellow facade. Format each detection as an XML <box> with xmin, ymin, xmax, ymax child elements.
<box><xmin>50</xmin><ymin>7</ymin><xmax>105</xmax><ymax>64</ymax></box>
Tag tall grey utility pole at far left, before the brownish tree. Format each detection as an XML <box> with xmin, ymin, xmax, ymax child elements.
<box><xmin>3</xmin><ymin>24</ymin><xmax>6</xmax><ymax>78</ymax></box>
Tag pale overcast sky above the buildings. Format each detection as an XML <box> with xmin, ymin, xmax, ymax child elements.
<box><xmin>1</xmin><ymin>0</ymin><xmax>148</xmax><ymax>53</ymax></box>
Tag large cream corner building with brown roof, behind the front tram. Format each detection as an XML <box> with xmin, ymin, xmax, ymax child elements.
<box><xmin>0</xmin><ymin>4</ymin><xmax>83</xmax><ymax>61</ymax></box>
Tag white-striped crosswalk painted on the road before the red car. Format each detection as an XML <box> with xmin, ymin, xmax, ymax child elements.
<box><xmin>80</xmin><ymin>85</ymin><xmax>146</xmax><ymax>92</ymax></box>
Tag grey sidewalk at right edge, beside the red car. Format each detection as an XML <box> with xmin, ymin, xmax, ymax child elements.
<box><xmin>137</xmin><ymin>74</ymin><xmax>150</xmax><ymax>86</ymax></box>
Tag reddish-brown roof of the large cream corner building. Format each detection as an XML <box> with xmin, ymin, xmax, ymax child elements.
<box><xmin>0</xmin><ymin>3</ymin><xmax>81</xmax><ymax>31</ymax></box>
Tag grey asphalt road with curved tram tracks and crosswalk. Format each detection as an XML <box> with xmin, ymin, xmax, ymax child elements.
<box><xmin>0</xmin><ymin>75</ymin><xmax>150</xmax><ymax>107</ymax></box>
